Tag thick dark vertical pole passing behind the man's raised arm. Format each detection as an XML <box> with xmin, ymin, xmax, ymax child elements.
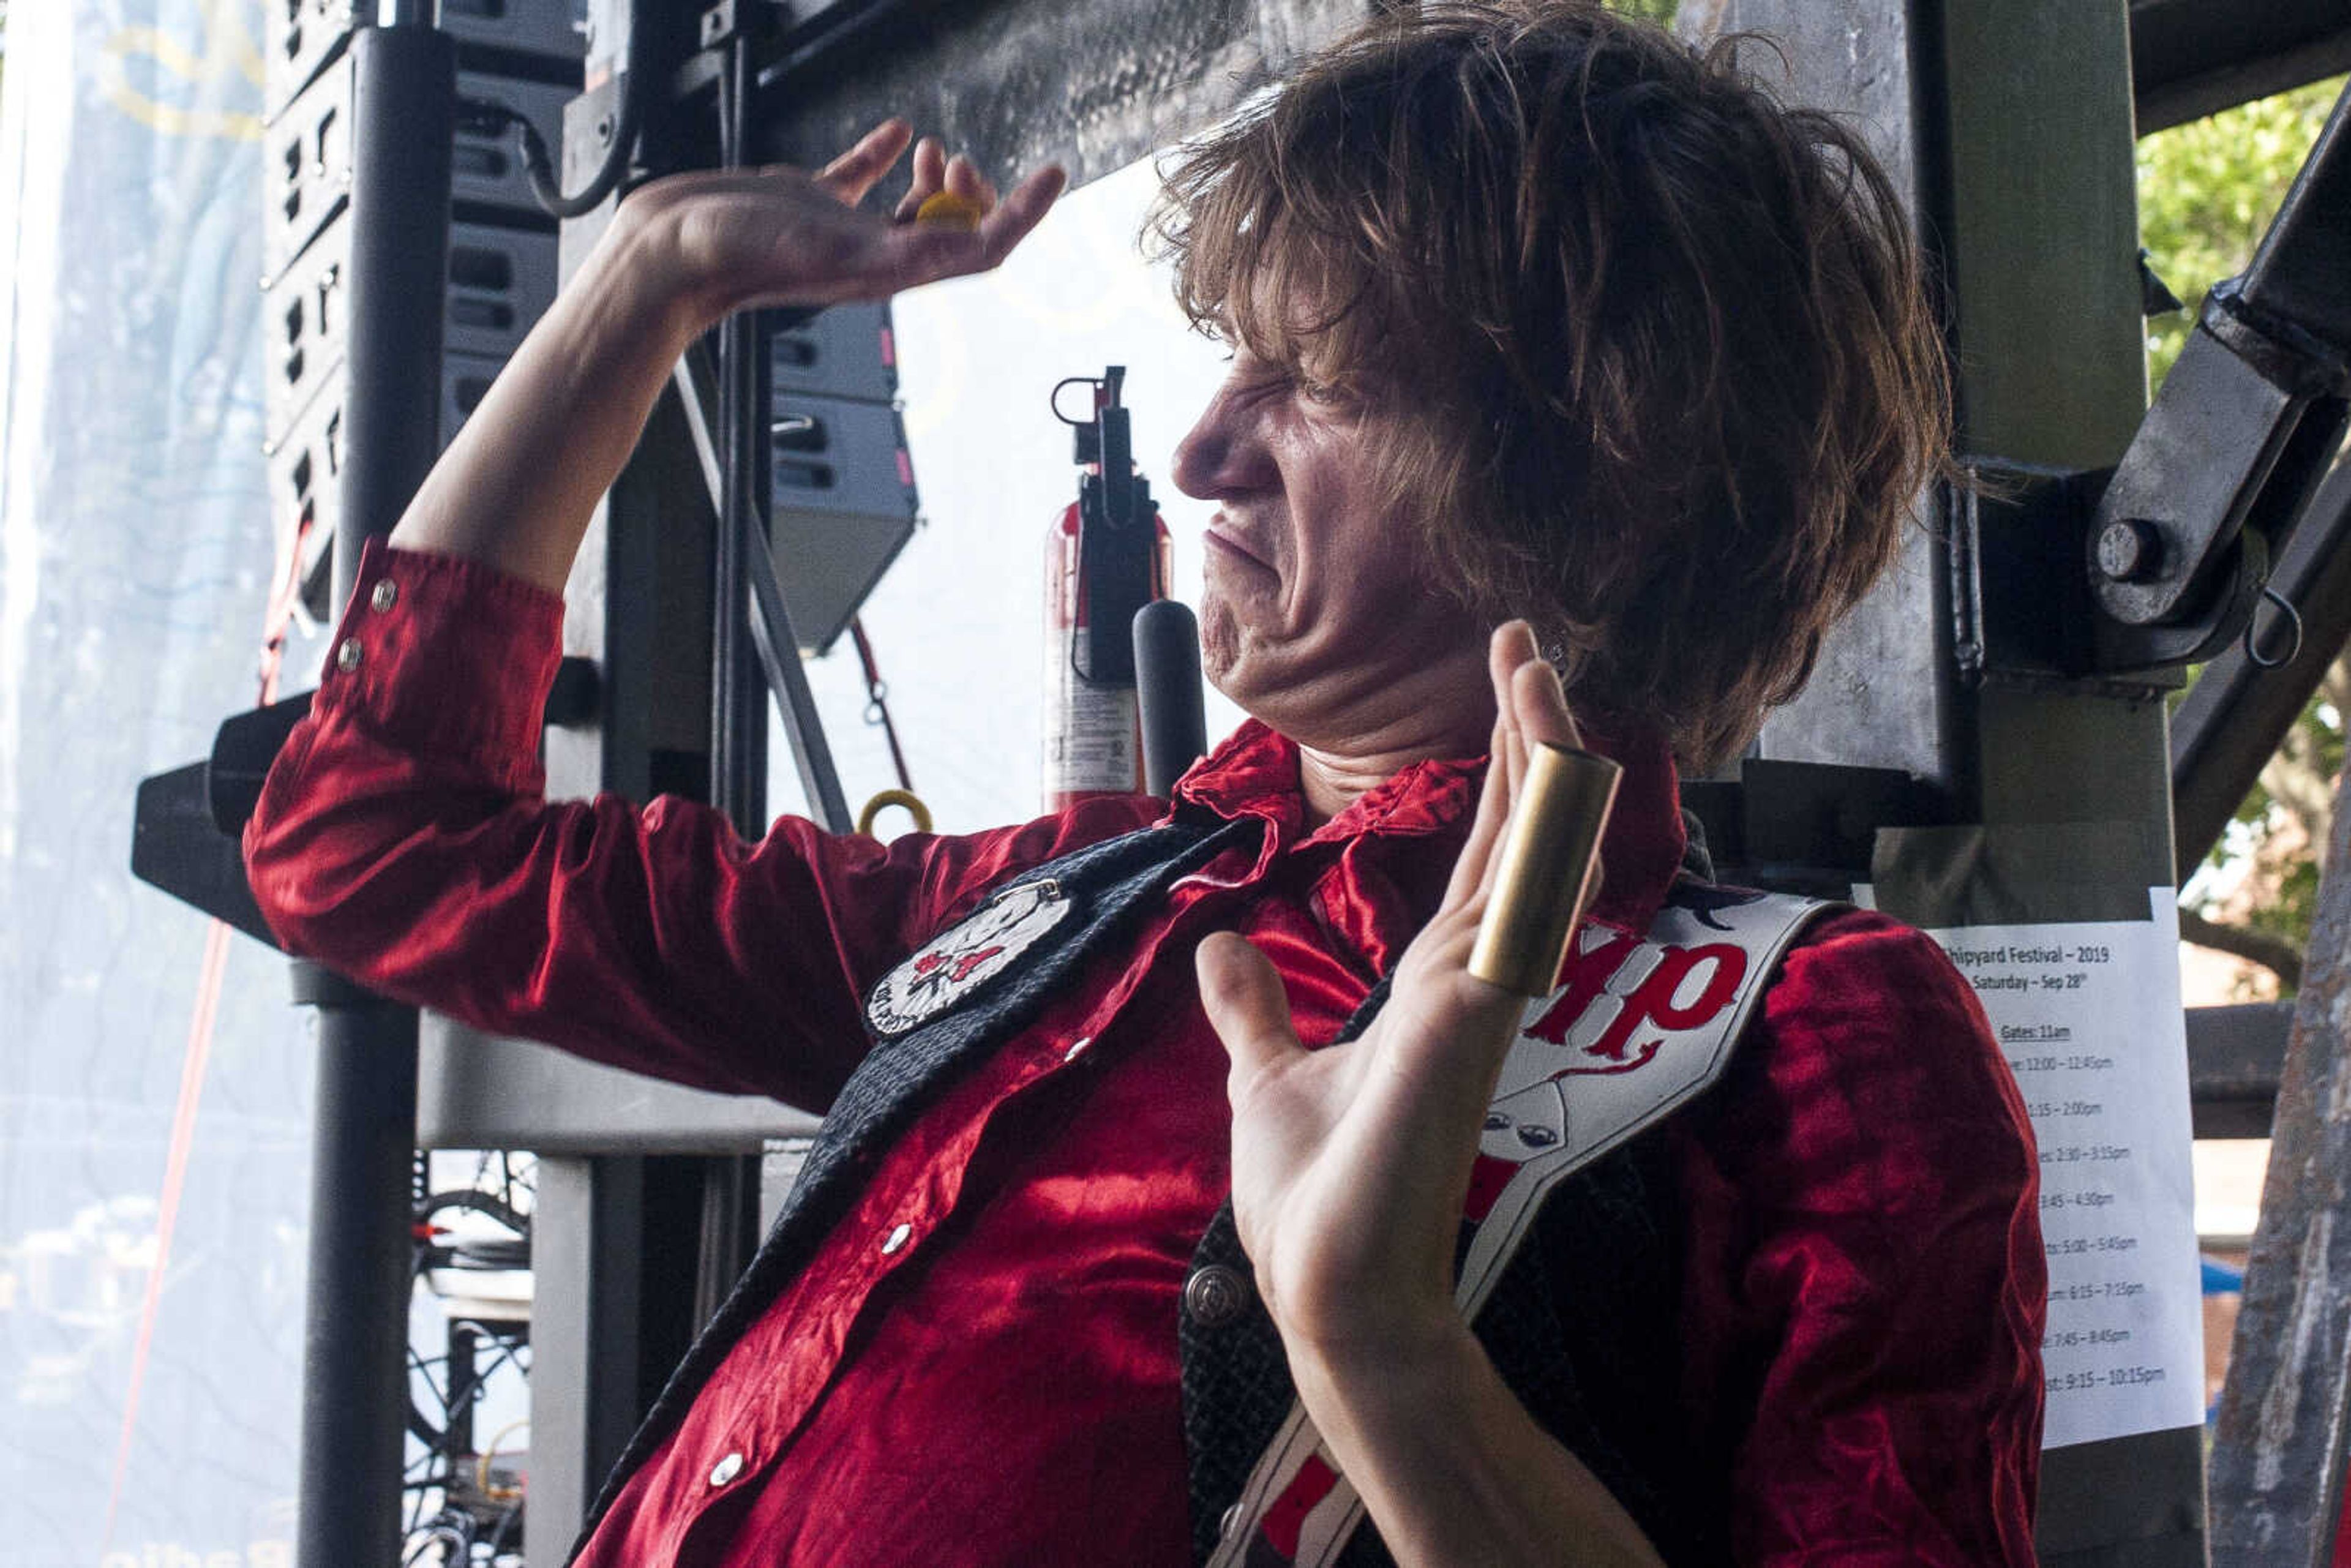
<box><xmin>294</xmin><ymin>23</ymin><xmax>456</xmax><ymax>1568</ymax></box>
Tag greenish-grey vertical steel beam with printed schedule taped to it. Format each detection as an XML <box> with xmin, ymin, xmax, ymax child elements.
<box><xmin>1914</xmin><ymin>0</ymin><xmax>2203</xmax><ymax>1568</ymax></box>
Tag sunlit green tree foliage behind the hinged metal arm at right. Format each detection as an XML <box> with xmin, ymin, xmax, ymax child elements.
<box><xmin>2139</xmin><ymin>78</ymin><xmax>2351</xmax><ymax>992</ymax></box>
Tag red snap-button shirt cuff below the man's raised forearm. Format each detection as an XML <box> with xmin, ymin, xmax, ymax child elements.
<box><xmin>310</xmin><ymin>538</ymin><xmax>564</xmax><ymax>787</ymax></box>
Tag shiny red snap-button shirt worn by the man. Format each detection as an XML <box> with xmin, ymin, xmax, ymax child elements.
<box><xmin>247</xmin><ymin>548</ymin><xmax>2043</xmax><ymax>1568</ymax></box>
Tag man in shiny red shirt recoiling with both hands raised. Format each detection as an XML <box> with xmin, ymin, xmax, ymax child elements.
<box><xmin>247</xmin><ymin>0</ymin><xmax>2045</xmax><ymax>1566</ymax></box>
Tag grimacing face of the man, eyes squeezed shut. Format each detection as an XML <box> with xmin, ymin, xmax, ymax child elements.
<box><xmin>1173</xmin><ymin>348</ymin><xmax>1483</xmax><ymax>745</ymax></box>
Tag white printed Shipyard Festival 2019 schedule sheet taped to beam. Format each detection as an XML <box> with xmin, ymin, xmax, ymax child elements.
<box><xmin>1928</xmin><ymin>888</ymin><xmax>2203</xmax><ymax>1448</ymax></box>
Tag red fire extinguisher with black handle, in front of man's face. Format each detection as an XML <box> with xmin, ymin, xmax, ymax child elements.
<box><xmin>1044</xmin><ymin>364</ymin><xmax>1173</xmax><ymax>811</ymax></box>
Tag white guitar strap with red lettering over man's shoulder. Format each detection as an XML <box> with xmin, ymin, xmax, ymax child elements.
<box><xmin>1209</xmin><ymin>882</ymin><xmax>1843</xmax><ymax>1568</ymax></box>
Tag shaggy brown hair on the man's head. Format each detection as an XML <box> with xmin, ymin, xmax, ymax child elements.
<box><xmin>1147</xmin><ymin>0</ymin><xmax>1949</xmax><ymax>769</ymax></box>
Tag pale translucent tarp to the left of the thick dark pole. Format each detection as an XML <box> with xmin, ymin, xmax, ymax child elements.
<box><xmin>0</xmin><ymin>0</ymin><xmax>315</xmax><ymax>1568</ymax></box>
